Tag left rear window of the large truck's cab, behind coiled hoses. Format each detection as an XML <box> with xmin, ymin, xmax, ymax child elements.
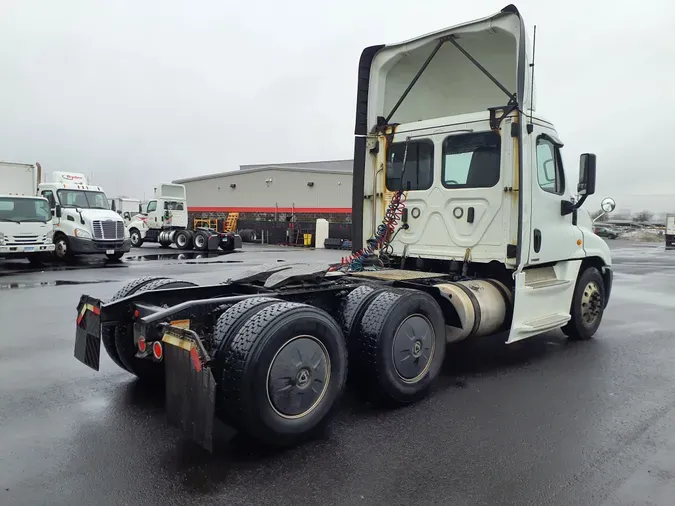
<box><xmin>386</xmin><ymin>140</ymin><xmax>434</xmax><ymax>191</ymax></box>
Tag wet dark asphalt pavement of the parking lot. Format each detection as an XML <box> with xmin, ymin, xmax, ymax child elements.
<box><xmin>0</xmin><ymin>241</ymin><xmax>675</xmax><ymax>506</ymax></box>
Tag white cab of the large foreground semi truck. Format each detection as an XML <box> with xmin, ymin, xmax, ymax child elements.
<box><xmin>353</xmin><ymin>5</ymin><xmax>612</xmax><ymax>343</ymax></box>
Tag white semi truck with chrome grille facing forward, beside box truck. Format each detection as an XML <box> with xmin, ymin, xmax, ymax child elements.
<box><xmin>38</xmin><ymin>171</ymin><xmax>131</xmax><ymax>260</ymax></box>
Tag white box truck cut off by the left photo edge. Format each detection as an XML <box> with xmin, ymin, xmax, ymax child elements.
<box><xmin>0</xmin><ymin>162</ymin><xmax>54</xmax><ymax>263</ymax></box>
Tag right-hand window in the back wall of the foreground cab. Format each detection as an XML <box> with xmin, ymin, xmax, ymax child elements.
<box><xmin>443</xmin><ymin>132</ymin><xmax>501</xmax><ymax>188</ymax></box>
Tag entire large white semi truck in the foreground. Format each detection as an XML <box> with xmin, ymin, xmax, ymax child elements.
<box><xmin>75</xmin><ymin>5</ymin><xmax>612</xmax><ymax>449</ymax></box>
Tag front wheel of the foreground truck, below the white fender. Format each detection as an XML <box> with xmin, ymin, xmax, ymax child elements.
<box><xmin>562</xmin><ymin>267</ymin><xmax>605</xmax><ymax>341</ymax></box>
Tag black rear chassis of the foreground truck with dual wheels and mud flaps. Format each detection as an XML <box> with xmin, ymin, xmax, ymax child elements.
<box><xmin>75</xmin><ymin>263</ymin><xmax>456</xmax><ymax>451</ymax></box>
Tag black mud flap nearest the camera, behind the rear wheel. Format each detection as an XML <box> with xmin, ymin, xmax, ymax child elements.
<box><xmin>162</xmin><ymin>327</ymin><xmax>216</xmax><ymax>452</ymax></box>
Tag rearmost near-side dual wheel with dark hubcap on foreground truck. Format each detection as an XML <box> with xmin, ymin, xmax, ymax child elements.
<box><xmin>219</xmin><ymin>302</ymin><xmax>347</xmax><ymax>446</ymax></box>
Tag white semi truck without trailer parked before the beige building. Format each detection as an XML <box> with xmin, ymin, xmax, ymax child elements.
<box><xmin>127</xmin><ymin>183</ymin><xmax>241</xmax><ymax>251</ymax></box>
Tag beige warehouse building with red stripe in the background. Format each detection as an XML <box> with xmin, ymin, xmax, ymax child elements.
<box><xmin>174</xmin><ymin>160</ymin><xmax>353</xmax><ymax>242</ymax></box>
